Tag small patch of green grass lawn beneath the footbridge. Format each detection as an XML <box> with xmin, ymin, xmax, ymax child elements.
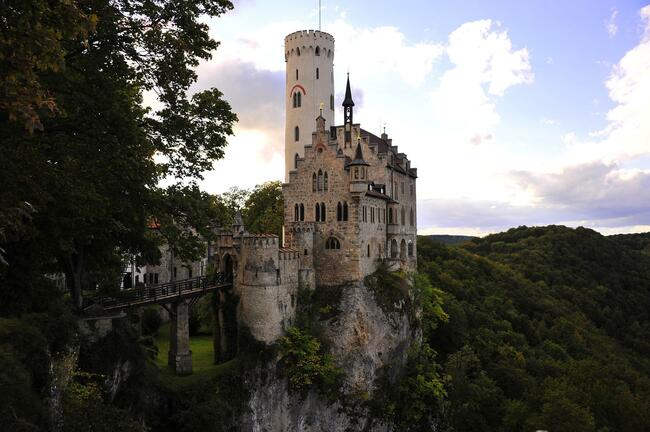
<box><xmin>155</xmin><ymin>323</ymin><xmax>236</xmax><ymax>390</ymax></box>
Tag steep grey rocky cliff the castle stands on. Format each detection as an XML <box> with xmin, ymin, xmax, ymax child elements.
<box><xmin>241</xmin><ymin>279</ymin><xmax>420</xmax><ymax>432</ymax></box>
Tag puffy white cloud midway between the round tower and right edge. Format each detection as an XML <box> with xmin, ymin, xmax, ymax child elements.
<box><xmin>432</xmin><ymin>19</ymin><xmax>533</xmax><ymax>137</ymax></box>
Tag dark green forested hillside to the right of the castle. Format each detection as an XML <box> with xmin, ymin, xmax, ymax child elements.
<box><xmin>418</xmin><ymin>226</ymin><xmax>650</xmax><ymax>432</ymax></box>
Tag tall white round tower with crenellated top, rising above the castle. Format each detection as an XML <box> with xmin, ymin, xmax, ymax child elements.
<box><xmin>284</xmin><ymin>30</ymin><xmax>334</xmax><ymax>181</ymax></box>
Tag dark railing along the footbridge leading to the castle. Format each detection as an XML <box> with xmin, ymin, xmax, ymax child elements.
<box><xmin>98</xmin><ymin>273</ymin><xmax>231</xmax><ymax>308</ymax></box>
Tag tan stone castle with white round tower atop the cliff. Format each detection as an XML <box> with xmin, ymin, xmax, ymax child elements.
<box><xmin>124</xmin><ymin>30</ymin><xmax>417</xmax><ymax>359</ymax></box>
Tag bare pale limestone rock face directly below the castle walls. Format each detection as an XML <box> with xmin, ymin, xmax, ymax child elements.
<box><xmin>241</xmin><ymin>282</ymin><xmax>420</xmax><ymax>432</ymax></box>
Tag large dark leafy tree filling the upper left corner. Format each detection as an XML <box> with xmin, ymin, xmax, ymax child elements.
<box><xmin>0</xmin><ymin>0</ymin><xmax>236</xmax><ymax>309</ymax></box>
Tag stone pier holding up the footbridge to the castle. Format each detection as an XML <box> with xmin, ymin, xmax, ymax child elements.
<box><xmin>167</xmin><ymin>300</ymin><xmax>192</xmax><ymax>375</ymax></box>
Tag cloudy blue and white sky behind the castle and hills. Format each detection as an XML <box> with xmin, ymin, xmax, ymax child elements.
<box><xmin>181</xmin><ymin>0</ymin><xmax>650</xmax><ymax>235</ymax></box>
